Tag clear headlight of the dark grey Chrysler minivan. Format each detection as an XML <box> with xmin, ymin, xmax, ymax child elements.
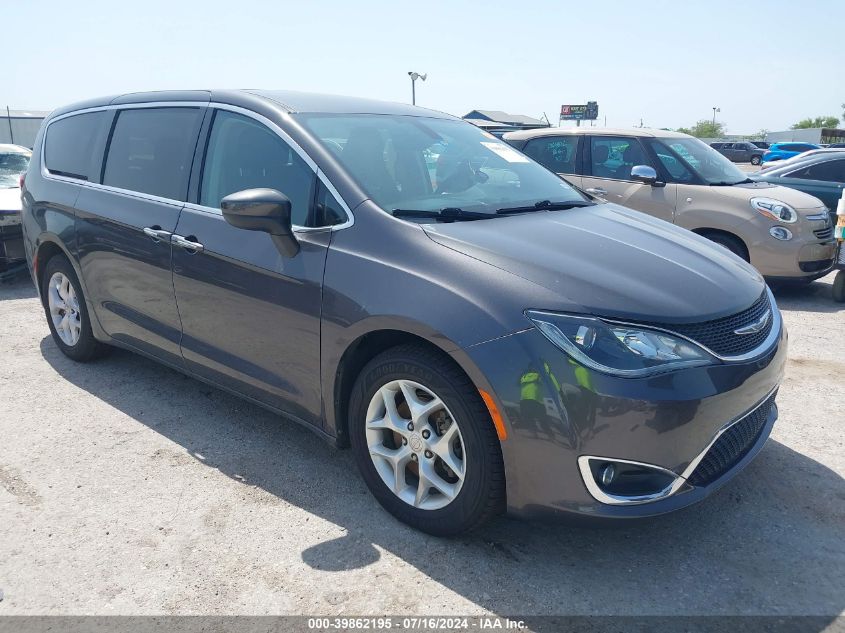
<box><xmin>525</xmin><ymin>310</ymin><xmax>718</xmax><ymax>378</ymax></box>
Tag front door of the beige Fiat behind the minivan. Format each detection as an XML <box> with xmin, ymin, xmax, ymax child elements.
<box><xmin>582</xmin><ymin>135</ymin><xmax>677</xmax><ymax>222</ymax></box>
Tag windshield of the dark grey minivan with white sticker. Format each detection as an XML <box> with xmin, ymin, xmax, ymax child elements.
<box><xmin>298</xmin><ymin>114</ymin><xmax>585</xmax><ymax>219</ymax></box>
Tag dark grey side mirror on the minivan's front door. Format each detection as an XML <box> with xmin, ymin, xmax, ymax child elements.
<box><xmin>220</xmin><ymin>189</ymin><xmax>299</xmax><ymax>257</ymax></box>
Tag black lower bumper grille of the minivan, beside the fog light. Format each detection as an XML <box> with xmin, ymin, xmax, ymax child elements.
<box><xmin>687</xmin><ymin>392</ymin><xmax>777</xmax><ymax>486</ymax></box>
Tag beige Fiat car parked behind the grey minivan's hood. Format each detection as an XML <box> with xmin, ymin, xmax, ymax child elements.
<box><xmin>504</xmin><ymin>127</ymin><xmax>836</xmax><ymax>281</ymax></box>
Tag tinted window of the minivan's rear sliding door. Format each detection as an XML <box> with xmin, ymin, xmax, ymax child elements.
<box><xmin>103</xmin><ymin>108</ymin><xmax>200</xmax><ymax>200</ymax></box>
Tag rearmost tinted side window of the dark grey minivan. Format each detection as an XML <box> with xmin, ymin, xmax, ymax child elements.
<box><xmin>44</xmin><ymin>111</ymin><xmax>107</xmax><ymax>180</ymax></box>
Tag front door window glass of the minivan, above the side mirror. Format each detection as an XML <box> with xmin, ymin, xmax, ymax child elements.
<box><xmin>200</xmin><ymin>110</ymin><xmax>315</xmax><ymax>226</ymax></box>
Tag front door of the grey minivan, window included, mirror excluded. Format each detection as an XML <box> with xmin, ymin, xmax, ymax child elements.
<box><xmin>173</xmin><ymin>109</ymin><xmax>342</xmax><ymax>424</ymax></box>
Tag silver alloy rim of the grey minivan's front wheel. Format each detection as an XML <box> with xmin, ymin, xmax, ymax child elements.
<box><xmin>366</xmin><ymin>380</ymin><xmax>467</xmax><ymax>510</ymax></box>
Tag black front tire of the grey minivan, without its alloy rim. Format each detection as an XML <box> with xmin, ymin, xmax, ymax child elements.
<box><xmin>349</xmin><ymin>350</ymin><xmax>501</xmax><ymax>536</ymax></box>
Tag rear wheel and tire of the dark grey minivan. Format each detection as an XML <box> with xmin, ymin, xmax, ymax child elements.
<box><xmin>41</xmin><ymin>255</ymin><xmax>108</xmax><ymax>363</ymax></box>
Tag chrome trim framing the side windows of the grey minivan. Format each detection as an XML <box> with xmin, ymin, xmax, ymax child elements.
<box><xmin>40</xmin><ymin>101</ymin><xmax>355</xmax><ymax>233</ymax></box>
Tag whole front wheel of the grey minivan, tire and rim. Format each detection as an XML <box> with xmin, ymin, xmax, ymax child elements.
<box><xmin>349</xmin><ymin>345</ymin><xmax>505</xmax><ymax>536</ymax></box>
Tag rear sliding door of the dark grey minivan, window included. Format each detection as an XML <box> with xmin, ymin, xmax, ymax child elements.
<box><xmin>76</xmin><ymin>106</ymin><xmax>204</xmax><ymax>367</ymax></box>
